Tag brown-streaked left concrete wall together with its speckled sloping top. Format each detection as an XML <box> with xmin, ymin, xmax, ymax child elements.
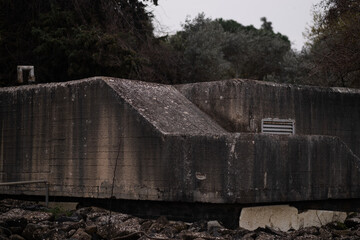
<box><xmin>0</xmin><ymin>79</ymin><xmax>224</xmax><ymax>200</ymax></box>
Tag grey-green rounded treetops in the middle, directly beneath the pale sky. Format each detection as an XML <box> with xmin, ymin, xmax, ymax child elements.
<box><xmin>170</xmin><ymin>14</ymin><xmax>290</xmax><ymax>81</ymax></box>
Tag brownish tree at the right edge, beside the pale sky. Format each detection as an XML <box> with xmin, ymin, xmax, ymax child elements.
<box><xmin>308</xmin><ymin>0</ymin><xmax>360</xmax><ymax>87</ymax></box>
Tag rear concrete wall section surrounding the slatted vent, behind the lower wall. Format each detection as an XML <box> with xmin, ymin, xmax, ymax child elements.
<box><xmin>177</xmin><ymin>80</ymin><xmax>360</xmax><ymax>156</ymax></box>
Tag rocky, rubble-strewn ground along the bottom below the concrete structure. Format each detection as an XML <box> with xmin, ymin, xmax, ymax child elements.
<box><xmin>0</xmin><ymin>199</ymin><xmax>360</xmax><ymax>240</ymax></box>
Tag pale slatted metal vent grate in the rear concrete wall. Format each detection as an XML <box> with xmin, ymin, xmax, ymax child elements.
<box><xmin>261</xmin><ymin>118</ymin><xmax>295</xmax><ymax>135</ymax></box>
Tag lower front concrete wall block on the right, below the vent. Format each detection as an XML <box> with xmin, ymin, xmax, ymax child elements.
<box><xmin>162</xmin><ymin>134</ymin><xmax>360</xmax><ymax>203</ymax></box>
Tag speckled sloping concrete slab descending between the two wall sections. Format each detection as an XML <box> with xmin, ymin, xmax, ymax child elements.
<box><xmin>105</xmin><ymin>78</ymin><xmax>226</xmax><ymax>135</ymax></box>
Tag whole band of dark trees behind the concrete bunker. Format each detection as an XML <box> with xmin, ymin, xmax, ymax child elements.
<box><xmin>7</xmin><ymin>0</ymin><xmax>360</xmax><ymax>87</ymax></box>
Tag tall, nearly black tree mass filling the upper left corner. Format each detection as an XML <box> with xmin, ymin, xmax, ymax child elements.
<box><xmin>0</xmin><ymin>0</ymin><xmax>170</xmax><ymax>85</ymax></box>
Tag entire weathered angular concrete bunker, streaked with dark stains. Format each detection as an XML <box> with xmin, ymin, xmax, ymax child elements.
<box><xmin>0</xmin><ymin>77</ymin><xmax>360</xmax><ymax>204</ymax></box>
